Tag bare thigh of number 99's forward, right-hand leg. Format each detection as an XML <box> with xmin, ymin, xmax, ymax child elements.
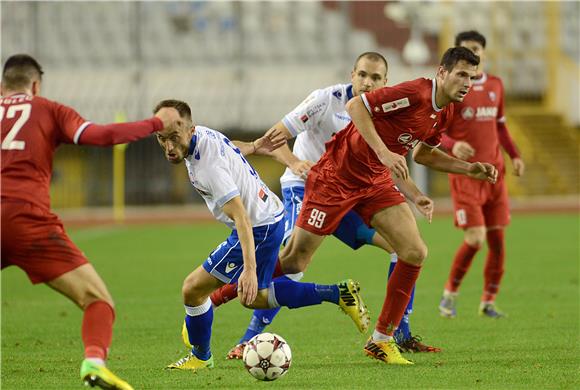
<box><xmin>371</xmin><ymin>203</ymin><xmax>427</xmax><ymax>264</ymax></box>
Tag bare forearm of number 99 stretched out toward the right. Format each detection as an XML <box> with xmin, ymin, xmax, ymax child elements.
<box><xmin>413</xmin><ymin>143</ymin><xmax>498</xmax><ymax>183</ymax></box>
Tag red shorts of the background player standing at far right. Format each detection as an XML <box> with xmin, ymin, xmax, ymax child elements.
<box><xmin>449</xmin><ymin>175</ymin><xmax>510</xmax><ymax>228</ymax></box>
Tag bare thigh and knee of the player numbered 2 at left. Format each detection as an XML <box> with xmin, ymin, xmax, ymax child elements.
<box><xmin>46</xmin><ymin>263</ymin><xmax>113</xmax><ymax>308</ymax></box>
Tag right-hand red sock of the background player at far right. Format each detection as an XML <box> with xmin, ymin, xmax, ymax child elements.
<box><xmin>481</xmin><ymin>229</ymin><xmax>505</xmax><ymax>302</ymax></box>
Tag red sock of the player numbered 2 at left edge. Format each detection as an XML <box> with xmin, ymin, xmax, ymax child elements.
<box><xmin>82</xmin><ymin>301</ymin><xmax>115</xmax><ymax>360</ymax></box>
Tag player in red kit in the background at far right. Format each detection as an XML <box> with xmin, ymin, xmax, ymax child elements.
<box><xmin>439</xmin><ymin>31</ymin><xmax>525</xmax><ymax>318</ymax></box>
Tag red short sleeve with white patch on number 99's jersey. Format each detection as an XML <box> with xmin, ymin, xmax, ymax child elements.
<box><xmin>361</xmin><ymin>83</ymin><xmax>418</xmax><ymax>117</ymax></box>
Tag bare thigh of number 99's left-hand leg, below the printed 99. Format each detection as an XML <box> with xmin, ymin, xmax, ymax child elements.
<box><xmin>280</xmin><ymin>226</ymin><xmax>326</xmax><ymax>274</ymax></box>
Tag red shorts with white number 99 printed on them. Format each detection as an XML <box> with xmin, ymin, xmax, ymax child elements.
<box><xmin>296</xmin><ymin>163</ymin><xmax>405</xmax><ymax>236</ymax></box>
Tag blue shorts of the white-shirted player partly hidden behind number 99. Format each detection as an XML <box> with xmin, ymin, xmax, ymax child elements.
<box><xmin>282</xmin><ymin>186</ymin><xmax>375</xmax><ymax>249</ymax></box>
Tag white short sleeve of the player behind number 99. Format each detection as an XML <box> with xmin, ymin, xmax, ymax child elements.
<box><xmin>282</xmin><ymin>89</ymin><xmax>329</xmax><ymax>137</ymax></box>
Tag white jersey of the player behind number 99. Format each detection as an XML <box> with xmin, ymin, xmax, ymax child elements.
<box><xmin>280</xmin><ymin>84</ymin><xmax>353</xmax><ymax>188</ymax></box>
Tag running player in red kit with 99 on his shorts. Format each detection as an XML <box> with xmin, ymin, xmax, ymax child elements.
<box><xmin>280</xmin><ymin>48</ymin><xmax>497</xmax><ymax>364</ymax></box>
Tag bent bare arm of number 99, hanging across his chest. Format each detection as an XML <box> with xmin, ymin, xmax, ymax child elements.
<box><xmin>346</xmin><ymin>96</ymin><xmax>409</xmax><ymax>180</ymax></box>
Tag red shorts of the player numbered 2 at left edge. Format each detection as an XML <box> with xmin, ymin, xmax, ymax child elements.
<box><xmin>1</xmin><ymin>199</ymin><xmax>88</xmax><ymax>284</ymax></box>
